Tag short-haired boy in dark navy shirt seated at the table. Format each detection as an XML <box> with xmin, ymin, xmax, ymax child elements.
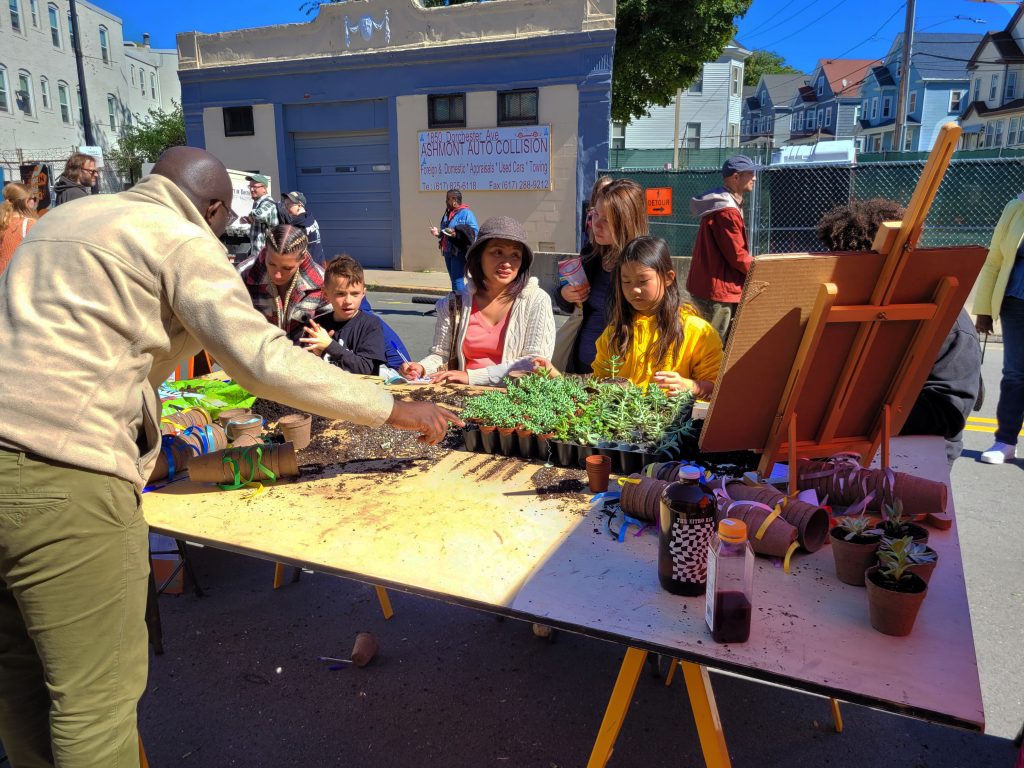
<box><xmin>300</xmin><ymin>254</ymin><xmax>386</xmax><ymax>374</ymax></box>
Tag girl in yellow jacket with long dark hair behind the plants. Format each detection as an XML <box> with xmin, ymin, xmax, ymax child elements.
<box><xmin>594</xmin><ymin>236</ymin><xmax>722</xmax><ymax>398</ymax></box>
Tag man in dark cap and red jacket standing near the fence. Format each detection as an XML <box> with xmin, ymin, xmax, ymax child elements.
<box><xmin>686</xmin><ymin>155</ymin><xmax>757</xmax><ymax>344</ymax></box>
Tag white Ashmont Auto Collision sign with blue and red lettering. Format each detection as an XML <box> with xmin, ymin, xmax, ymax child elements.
<box><xmin>419</xmin><ymin>125</ymin><xmax>552</xmax><ymax>191</ymax></box>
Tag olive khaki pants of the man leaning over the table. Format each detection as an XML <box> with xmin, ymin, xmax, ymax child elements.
<box><xmin>0</xmin><ymin>449</ymin><xmax>150</xmax><ymax>768</ymax></box>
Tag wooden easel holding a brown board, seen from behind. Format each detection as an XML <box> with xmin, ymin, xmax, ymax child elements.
<box><xmin>700</xmin><ymin>124</ymin><xmax>986</xmax><ymax>490</ymax></box>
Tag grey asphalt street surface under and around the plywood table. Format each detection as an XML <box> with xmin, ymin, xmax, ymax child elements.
<box><xmin>121</xmin><ymin>294</ymin><xmax>1024</xmax><ymax>768</ymax></box>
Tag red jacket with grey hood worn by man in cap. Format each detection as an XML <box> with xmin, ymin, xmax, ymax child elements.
<box><xmin>686</xmin><ymin>188</ymin><xmax>752</xmax><ymax>304</ymax></box>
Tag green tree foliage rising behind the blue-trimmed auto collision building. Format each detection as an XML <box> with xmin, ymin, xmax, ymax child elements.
<box><xmin>299</xmin><ymin>0</ymin><xmax>752</xmax><ymax>123</ymax></box>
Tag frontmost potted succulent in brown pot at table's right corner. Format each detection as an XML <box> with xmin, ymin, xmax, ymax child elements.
<box><xmin>864</xmin><ymin>548</ymin><xmax>928</xmax><ymax>637</ymax></box>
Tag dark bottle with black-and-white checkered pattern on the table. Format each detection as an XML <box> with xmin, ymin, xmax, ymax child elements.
<box><xmin>657</xmin><ymin>467</ymin><xmax>715</xmax><ymax>596</ymax></box>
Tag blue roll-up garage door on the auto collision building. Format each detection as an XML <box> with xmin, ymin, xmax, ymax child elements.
<box><xmin>292</xmin><ymin>131</ymin><xmax>394</xmax><ymax>268</ymax></box>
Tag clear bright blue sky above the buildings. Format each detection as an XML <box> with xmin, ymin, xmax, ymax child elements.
<box><xmin>98</xmin><ymin>0</ymin><xmax>1016</xmax><ymax>72</ymax></box>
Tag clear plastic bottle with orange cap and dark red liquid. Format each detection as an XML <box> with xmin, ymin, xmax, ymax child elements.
<box><xmin>705</xmin><ymin>517</ymin><xmax>754</xmax><ymax>643</ymax></box>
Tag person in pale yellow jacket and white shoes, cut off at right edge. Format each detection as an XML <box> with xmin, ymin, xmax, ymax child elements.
<box><xmin>974</xmin><ymin>196</ymin><xmax>1024</xmax><ymax>464</ymax></box>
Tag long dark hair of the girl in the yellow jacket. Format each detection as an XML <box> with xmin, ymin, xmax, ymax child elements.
<box><xmin>608</xmin><ymin>234</ymin><xmax>683</xmax><ymax>366</ymax></box>
